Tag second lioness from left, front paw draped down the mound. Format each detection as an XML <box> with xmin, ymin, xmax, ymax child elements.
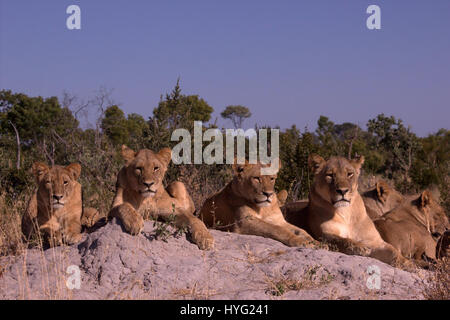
<box><xmin>109</xmin><ymin>146</ymin><xmax>214</xmax><ymax>249</ymax></box>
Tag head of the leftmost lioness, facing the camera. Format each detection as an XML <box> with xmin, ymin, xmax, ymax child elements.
<box><xmin>32</xmin><ymin>162</ymin><xmax>81</xmax><ymax>210</ymax></box>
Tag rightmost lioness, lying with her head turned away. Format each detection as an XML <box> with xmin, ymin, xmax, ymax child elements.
<box><xmin>374</xmin><ymin>190</ymin><xmax>449</xmax><ymax>260</ymax></box>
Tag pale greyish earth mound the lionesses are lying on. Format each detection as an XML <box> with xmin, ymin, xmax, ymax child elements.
<box><xmin>0</xmin><ymin>220</ymin><xmax>424</xmax><ymax>299</ymax></box>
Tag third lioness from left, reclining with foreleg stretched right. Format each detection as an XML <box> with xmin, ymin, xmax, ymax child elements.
<box><xmin>200</xmin><ymin>162</ymin><xmax>315</xmax><ymax>246</ymax></box>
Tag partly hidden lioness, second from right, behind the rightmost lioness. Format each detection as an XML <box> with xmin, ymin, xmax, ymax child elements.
<box><xmin>361</xmin><ymin>180</ymin><xmax>405</xmax><ymax>220</ymax></box>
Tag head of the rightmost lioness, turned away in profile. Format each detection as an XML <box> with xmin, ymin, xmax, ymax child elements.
<box><xmin>408</xmin><ymin>190</ymin><xmax>449</xmax><ymax>238</ymax></box>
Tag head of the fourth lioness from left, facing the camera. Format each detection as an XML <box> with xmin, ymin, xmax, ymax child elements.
<box><xmin>308</xmin><ymin>154</ymin><xmax>364</xmax><ymax>208</ymax></box>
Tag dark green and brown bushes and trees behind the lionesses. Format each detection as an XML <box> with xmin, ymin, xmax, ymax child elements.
<box><xmin>0</xmin><ymin>85</ymin><xmax>450</xmax><ymax>258</ymax></box>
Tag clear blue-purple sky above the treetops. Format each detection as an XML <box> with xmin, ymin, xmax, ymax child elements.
<box><xmin>0</xmin><ymin>0</ymin><xmax>450</xmax><ymax>136</ymax></box>
